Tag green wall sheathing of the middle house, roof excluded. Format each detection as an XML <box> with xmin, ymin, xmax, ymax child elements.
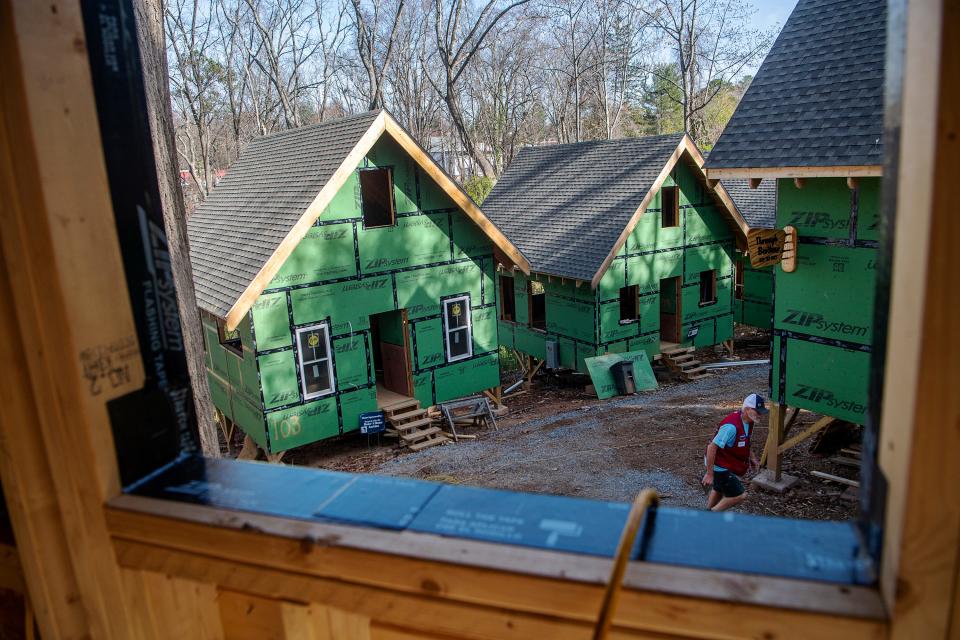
<box><xmin>498</xmin><ymin>157</ymin><xmax>736</xmax><ymax>373</ymax></box>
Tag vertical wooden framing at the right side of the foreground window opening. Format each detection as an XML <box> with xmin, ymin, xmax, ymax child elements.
<box><xmin>879</xmin><ymin>0</ymin><xmax>960</xmax><ymax>639</ymax></box>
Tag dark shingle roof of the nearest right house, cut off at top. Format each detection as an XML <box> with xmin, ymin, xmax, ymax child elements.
<box><xmin>707</xmin><ymin>0</ymin><xmax>887</xmax><ymax>169</ymax></box>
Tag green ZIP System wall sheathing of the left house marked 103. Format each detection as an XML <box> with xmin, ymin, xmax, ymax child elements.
<box><xmin>204</xmin><ymin>138</ymin><xmax>500</xmax><ymax>453</ymax></box>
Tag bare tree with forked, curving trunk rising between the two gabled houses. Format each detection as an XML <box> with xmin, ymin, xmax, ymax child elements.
<box><xmin>433</xmin><ymin>0</ymin><xmax>530</xmax><ymax>178</ymax></box>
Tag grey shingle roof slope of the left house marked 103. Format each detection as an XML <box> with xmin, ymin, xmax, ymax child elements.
<box><xmin>187</xmin><ymin>111</ymin><xmax>380</xmax><ymax>317</ymax></box>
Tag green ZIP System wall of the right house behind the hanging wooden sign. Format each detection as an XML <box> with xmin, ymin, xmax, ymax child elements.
<box><xmin>770</xmin><ymin>178</ymin><xmax>880</xmax><ymax>424</ymax></box>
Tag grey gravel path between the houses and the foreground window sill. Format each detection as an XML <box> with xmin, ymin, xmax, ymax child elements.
<box><xmin>371</xmin><ymin>367</ymin><xmax>767</xmax><ymax>507</ymax></box>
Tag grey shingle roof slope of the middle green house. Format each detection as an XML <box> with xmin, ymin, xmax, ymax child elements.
<box><xmin>483</xmin><ymin>133</ymin><xmax>683</xmax><ymax>281</ymax></box>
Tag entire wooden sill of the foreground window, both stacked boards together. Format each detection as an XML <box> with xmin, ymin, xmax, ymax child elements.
<box><xmin>106</xmin><ymin>495</ymin><xmax>885</xmax><ymax>640</ymax></box>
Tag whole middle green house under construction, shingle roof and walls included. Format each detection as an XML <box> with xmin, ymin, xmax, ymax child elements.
<box><xmin>483</xmin><ymin>134</ymin><xmax>747</xmax><ymax>377</ymax></box>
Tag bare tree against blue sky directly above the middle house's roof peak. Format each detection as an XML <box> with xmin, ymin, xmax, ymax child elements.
<box><xmin>638</xmin><ymin>0</ymin><xmax>772</xmax><ymax>139</ymax></box>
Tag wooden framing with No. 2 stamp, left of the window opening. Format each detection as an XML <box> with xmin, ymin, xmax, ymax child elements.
<box><xmin>0</xmin><ymin>2</ymin><xmax>144</xmax><ymax>638</ymax></box>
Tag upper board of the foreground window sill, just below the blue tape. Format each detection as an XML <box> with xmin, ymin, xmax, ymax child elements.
<box><xmin>108</xmin><ymin>496</ymin><xmax>882</xmax><ymax>624</ymax></box>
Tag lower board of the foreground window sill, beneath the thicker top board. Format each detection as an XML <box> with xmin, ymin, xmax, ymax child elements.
<box><xmin>116</xmin><ymin>541</ymin><xmax>884</xmax><ymax>640</ymax></box>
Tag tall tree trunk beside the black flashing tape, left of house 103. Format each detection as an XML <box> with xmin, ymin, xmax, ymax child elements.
<box><xmin>133</xmin><ymin>0</ymin><xmax>220</xmax><ymax>457</ymax></box>
